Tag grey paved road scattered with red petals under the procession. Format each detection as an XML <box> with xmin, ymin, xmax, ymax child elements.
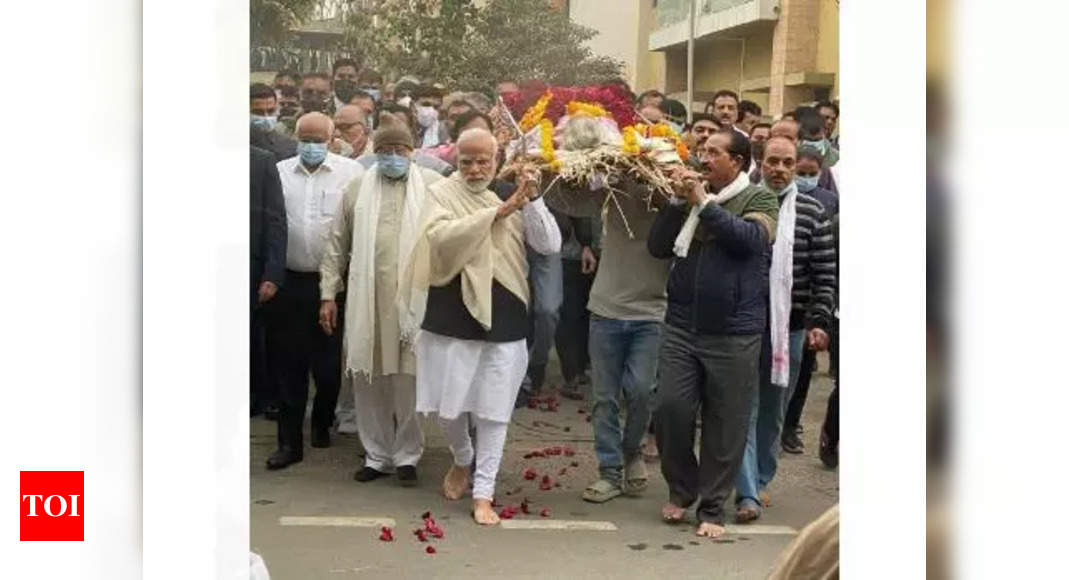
<box><xmin>250</xmin><ymin>358</ymin><xmax>838</xmax><ymax>580</ymax></box>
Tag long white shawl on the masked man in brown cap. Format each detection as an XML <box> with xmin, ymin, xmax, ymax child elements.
<box><xmin>344</xmin><ymin>164</ymin><xmax>427</xmax><ymax>379</ymax></box>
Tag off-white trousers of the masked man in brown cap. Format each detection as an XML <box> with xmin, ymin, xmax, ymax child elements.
<box><xmin>353</xmin><ymin>375</ymin><xmax>423</xmax><ymax>473</ymax></box>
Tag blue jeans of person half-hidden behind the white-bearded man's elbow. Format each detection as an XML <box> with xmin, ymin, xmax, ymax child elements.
<box><xmin>524</xmin><ymin>249</ymin><xmax>564</xmax><ymax>391</ymax></box>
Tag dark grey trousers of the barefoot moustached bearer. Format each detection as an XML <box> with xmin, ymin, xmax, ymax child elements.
<box><xmin>654</xmin><ymin>325</ymin><xmax>761</xmax><ymax>523</ymax></box>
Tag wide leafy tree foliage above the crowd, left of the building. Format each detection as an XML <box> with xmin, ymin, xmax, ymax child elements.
<box><xmin>345</xmin><ymin>0</ymin><xmax>622</xmax><ymax>91</ymax></box>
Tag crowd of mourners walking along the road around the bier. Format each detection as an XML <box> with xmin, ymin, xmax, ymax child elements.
<box><xmin>250</xmin><ymin>59</ymin><xmax>839</xmax><ymax>537</ymax></box>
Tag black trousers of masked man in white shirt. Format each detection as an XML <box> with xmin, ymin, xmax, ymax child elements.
<box><xmin>269</xmin><ymin>271</ymin><xmax>345</xmax><ymax>452</ymax></box>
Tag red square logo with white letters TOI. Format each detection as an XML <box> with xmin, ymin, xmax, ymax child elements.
<box><xmin>18</xmin><ymin>471</ymin><xmax>86</xmax><ymax>542</ymax></box>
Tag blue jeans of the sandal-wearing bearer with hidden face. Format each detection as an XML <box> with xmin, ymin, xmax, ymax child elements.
<box><xmin>590</xmin><ymin>314</ymin><xmax>663</xmax><ymax>485</ymax></box>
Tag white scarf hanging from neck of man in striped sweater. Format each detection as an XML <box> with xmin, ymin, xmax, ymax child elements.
<box><xmin>769</xmin><ymin>181</ymin><xmax>799</xmax><ymax>388</ymax></box>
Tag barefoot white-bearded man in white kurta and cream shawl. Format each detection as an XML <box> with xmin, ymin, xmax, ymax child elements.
<box><xmin>399</xmin><ymin>128</ymin><xmax>560</xmax><ymax>524</ymax></box>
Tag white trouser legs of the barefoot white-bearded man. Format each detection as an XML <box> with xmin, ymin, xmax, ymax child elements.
<box><xmin>438</xmin><ymin>413</ymin><xmax>509</xmax><ymax>500</ymax></box>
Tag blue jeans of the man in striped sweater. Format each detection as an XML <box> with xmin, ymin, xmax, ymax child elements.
<box><xmin>735</xmin><ymin>330</ymin><xmax>805</xmax><ymax>505</ymax></box>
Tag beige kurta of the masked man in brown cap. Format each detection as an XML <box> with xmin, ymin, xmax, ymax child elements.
<box><xmin>320</xmin><ymin>166</ymin><xmax>439</xmax><ymax>378</ymax></box>
